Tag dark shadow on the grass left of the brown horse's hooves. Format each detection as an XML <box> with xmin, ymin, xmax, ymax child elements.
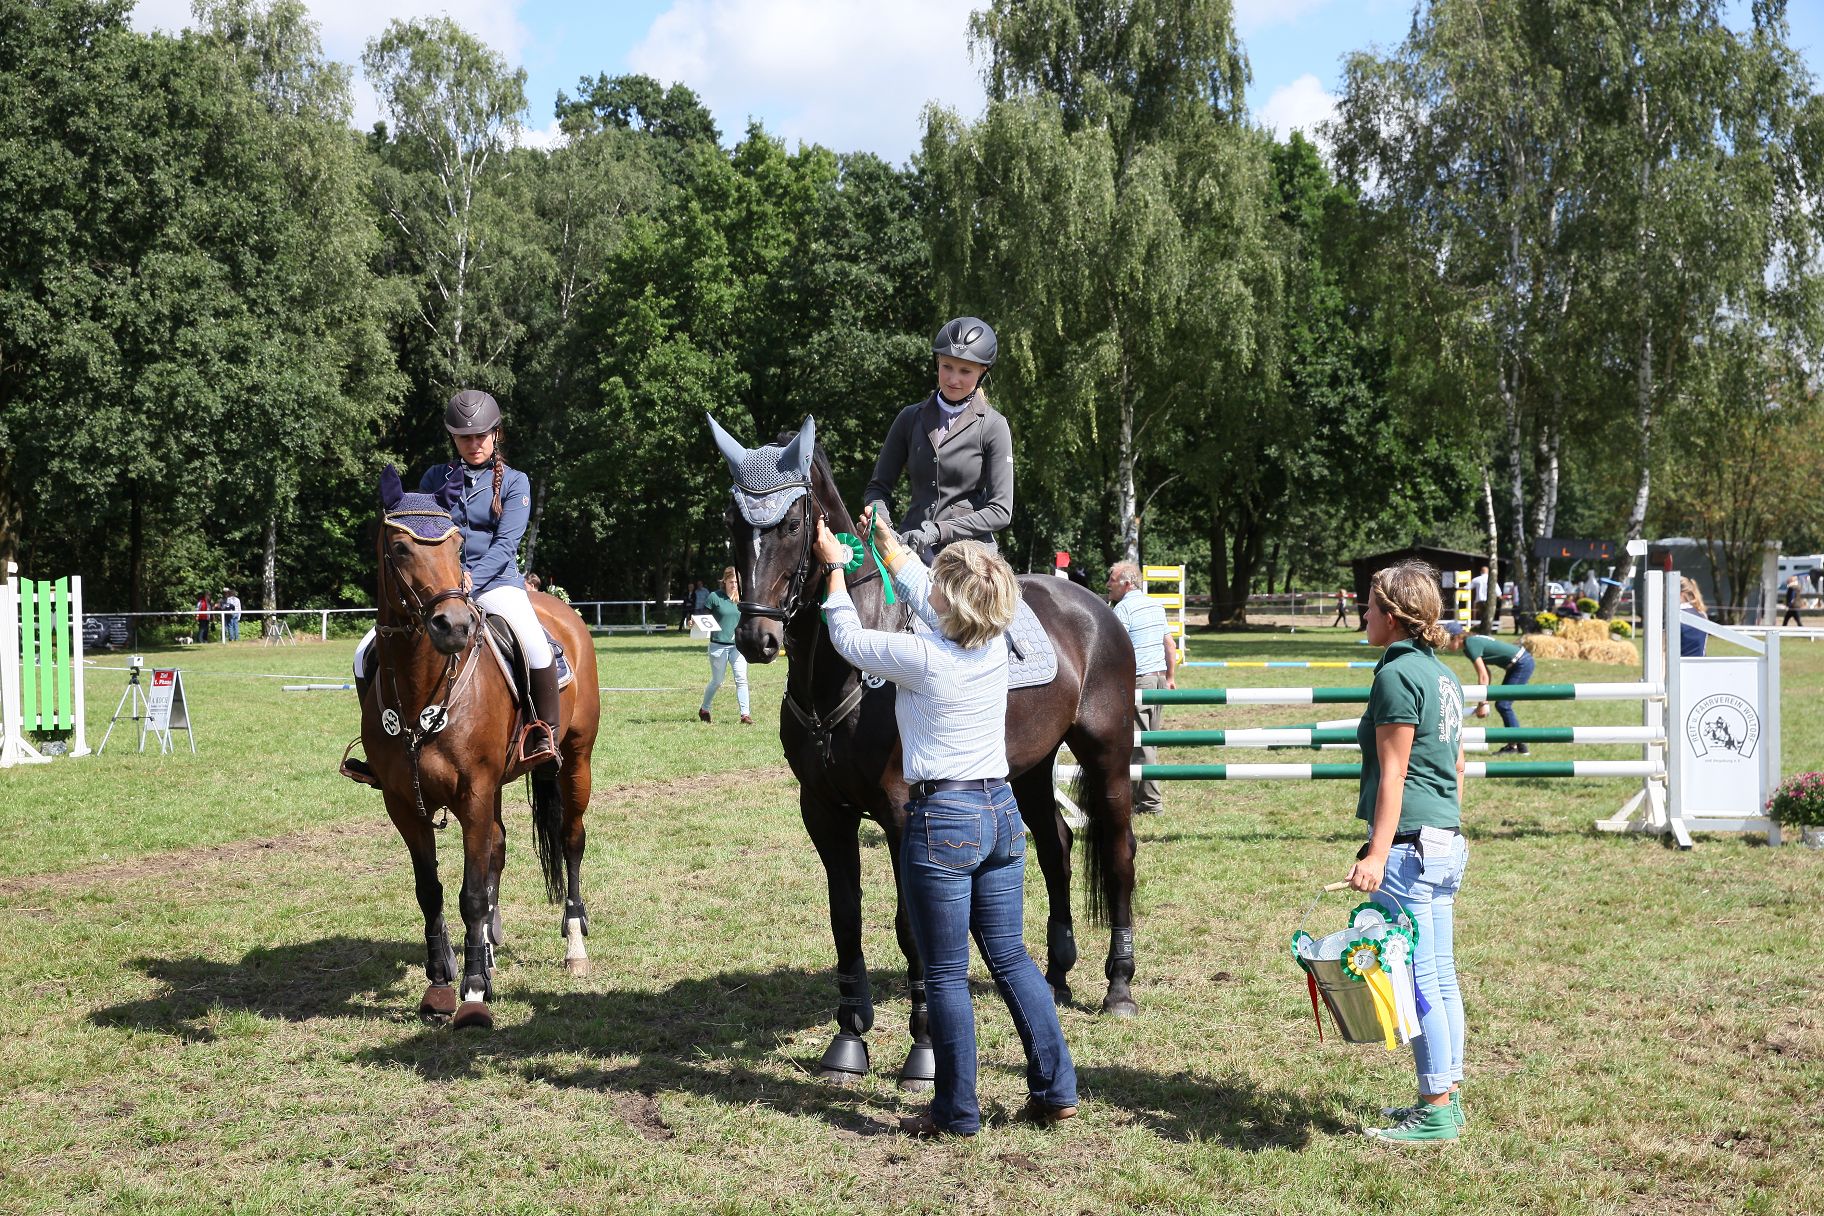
<box><xmin>89</xmin><ymin>937</ymin><xmax>423</xmax><ymax>1043</ymax></box>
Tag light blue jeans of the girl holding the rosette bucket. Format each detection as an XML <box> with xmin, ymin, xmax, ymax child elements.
<box><xmin>1375</xmin><ymin>837</ymin><xmax>1470</xmax><ymax>1094</ymax></box>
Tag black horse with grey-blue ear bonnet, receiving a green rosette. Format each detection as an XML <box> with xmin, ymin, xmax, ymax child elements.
<box><xmin>710</xmin><ymin>417</ymin><xmax>1138</xmax><ymax>1088</ymax></box>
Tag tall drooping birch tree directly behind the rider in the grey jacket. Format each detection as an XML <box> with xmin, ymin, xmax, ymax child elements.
<box><xmin>923</xmin><ymin>0</ymin><xmax>1275</xmax><ymax>558</ymax></box>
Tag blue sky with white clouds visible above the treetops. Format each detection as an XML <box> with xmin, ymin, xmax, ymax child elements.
<box><xmin>135</xmin><ymin>0</ymin><xmax>1824</xmax><ymax>160</ymax></box>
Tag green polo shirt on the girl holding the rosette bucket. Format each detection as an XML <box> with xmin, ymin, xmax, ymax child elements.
<box><xmin>1355</xmin><ymin>638</ymin><xmax>1463</xmax><ymax>831</ymax></box>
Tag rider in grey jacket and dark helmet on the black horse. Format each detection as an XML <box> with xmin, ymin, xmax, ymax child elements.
<box><xmin>863</xmin><ymin>317</ymin><xmax>1014</xmax><ymax>565</ymax></box>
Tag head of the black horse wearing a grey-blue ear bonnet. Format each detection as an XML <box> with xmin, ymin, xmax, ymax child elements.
<box><xmin>710</xmin><ymin>417</ymin><xmax>841</xmax><ymax>664</ymax></box>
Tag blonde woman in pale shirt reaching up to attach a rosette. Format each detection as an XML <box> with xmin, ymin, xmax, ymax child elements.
<box><xmin>815</xmin><ymin>510</ymin><xmax>1076</xmax><ymax>1138</ymax></box>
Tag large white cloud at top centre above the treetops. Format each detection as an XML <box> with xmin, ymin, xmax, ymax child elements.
<box><xmin>627</xmin><ymin>0</ymin><xmax>983</xmax><ymax>160</ymax></box>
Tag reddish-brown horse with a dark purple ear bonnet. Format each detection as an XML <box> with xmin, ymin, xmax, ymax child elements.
<box><xmin>361</xmin><ymin>465</ymin><xmax>602</xmax><ymax>1028</ymax></box>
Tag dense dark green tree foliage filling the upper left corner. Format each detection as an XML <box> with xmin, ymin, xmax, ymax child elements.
<box><xmin>0</xmin><ymin>0</ymin><xmax>392</xmax><ymax>607</ymax></box>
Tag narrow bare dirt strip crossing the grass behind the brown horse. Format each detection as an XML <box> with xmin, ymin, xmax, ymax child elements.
<box><xmin>0</xmin><ymin>764</ymin><xmax>792</xmax><ymax>901</ymax></box>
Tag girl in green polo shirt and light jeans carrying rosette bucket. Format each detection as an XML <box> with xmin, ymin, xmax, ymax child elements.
<box><xmin>1350</xmin><ymin>562</ymin><xmax>1468</xmax><ymax>1143</ymax></box>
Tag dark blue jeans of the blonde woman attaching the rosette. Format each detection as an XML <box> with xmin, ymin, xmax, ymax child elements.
<box><xmin>899</xmin><ymin>782</ymin><xmax>1076</xmax><ymax>1136</ymax></box>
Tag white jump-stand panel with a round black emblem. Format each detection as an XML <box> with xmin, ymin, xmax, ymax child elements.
<box><xmin>1667</xmin><ymin>656</ymin><xmax>1766</xmax><ymax>819</ymax></box>
